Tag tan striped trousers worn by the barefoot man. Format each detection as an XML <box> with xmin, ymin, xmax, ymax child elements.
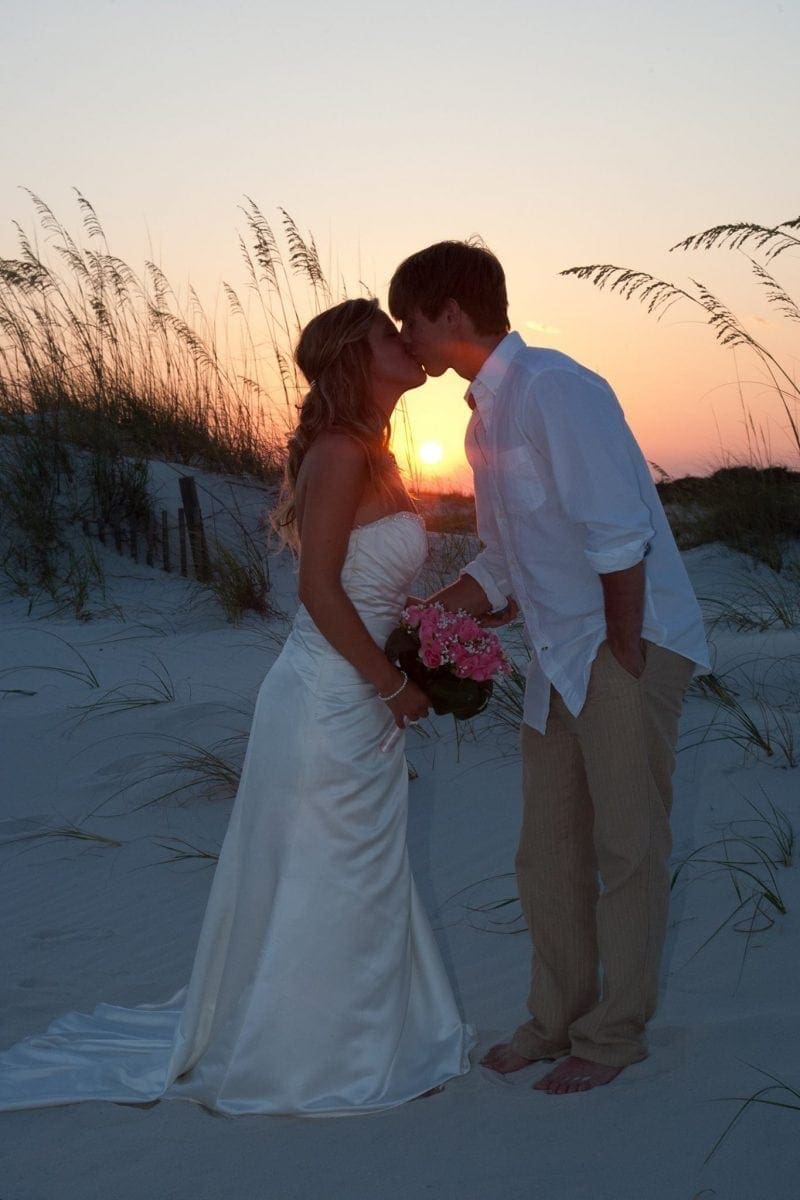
<box><xmin>513</xmin><ymin>643</ymin><xmax>693</xmax><ymax>1067</ymax></box>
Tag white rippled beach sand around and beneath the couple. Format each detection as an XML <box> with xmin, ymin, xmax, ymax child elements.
<box><xmin>0</xmin><ymin>468</ymin><xmax>800</xmax><ymax>1200</ymax></box>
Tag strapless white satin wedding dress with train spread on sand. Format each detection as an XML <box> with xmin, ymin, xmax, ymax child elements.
<box><xmin>0</xmin><ymin>512</ymin><xmax>474</xmax><ymax>1116</ymax></box>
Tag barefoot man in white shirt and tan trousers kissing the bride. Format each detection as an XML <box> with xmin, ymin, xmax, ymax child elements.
<box><xmin>389</xmin><ymin>241</ymin><xmax>708</xmax><ymax>1094</ymax></box>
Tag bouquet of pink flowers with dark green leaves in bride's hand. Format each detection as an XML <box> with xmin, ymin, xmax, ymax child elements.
<box><xmin>380</xmin><ymin>604</ymin><xmax>511</xmax><ymax>750</ymax></box>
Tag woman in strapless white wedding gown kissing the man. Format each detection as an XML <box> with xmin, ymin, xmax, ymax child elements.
<box><xmin>0</xmin><ymin>299</ymin><xmax>473</xmax><ymax>1116</ymax></box>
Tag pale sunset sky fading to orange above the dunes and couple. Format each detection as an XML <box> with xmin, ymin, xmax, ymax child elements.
<box><xmin>6</xmin><ymin>0</ymin><xmax>800</xmax><ymax>486</ymax></box>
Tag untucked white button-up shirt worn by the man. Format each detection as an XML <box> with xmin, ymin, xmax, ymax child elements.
<box><xmin>464</xmin><ymin>332</ymin><xmax>709</xmax><ymax>732</ymax></box>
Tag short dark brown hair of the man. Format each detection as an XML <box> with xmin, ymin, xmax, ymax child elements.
<box><xmin>389</xmin><ymin>238</ymin><xmax>510</xmax><ymax>335</ymax></box>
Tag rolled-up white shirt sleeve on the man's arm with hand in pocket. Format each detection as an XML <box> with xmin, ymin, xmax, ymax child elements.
<box><xmin>528</xmin><ymin>370</ymin><xmax>655</xmax><ymax>575</ymax></box>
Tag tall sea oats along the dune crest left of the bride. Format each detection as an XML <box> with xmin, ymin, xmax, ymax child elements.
<box><xmin>0</xmin><ymin>192</ymin><xmax>332</xmax><ymax>480</ymax></box>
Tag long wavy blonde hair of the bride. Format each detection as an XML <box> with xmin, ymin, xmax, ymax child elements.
<box><xmin>270</xmin><ymin>299</ymin><xmax>395</xmax><ymax>546</ymax></box>
